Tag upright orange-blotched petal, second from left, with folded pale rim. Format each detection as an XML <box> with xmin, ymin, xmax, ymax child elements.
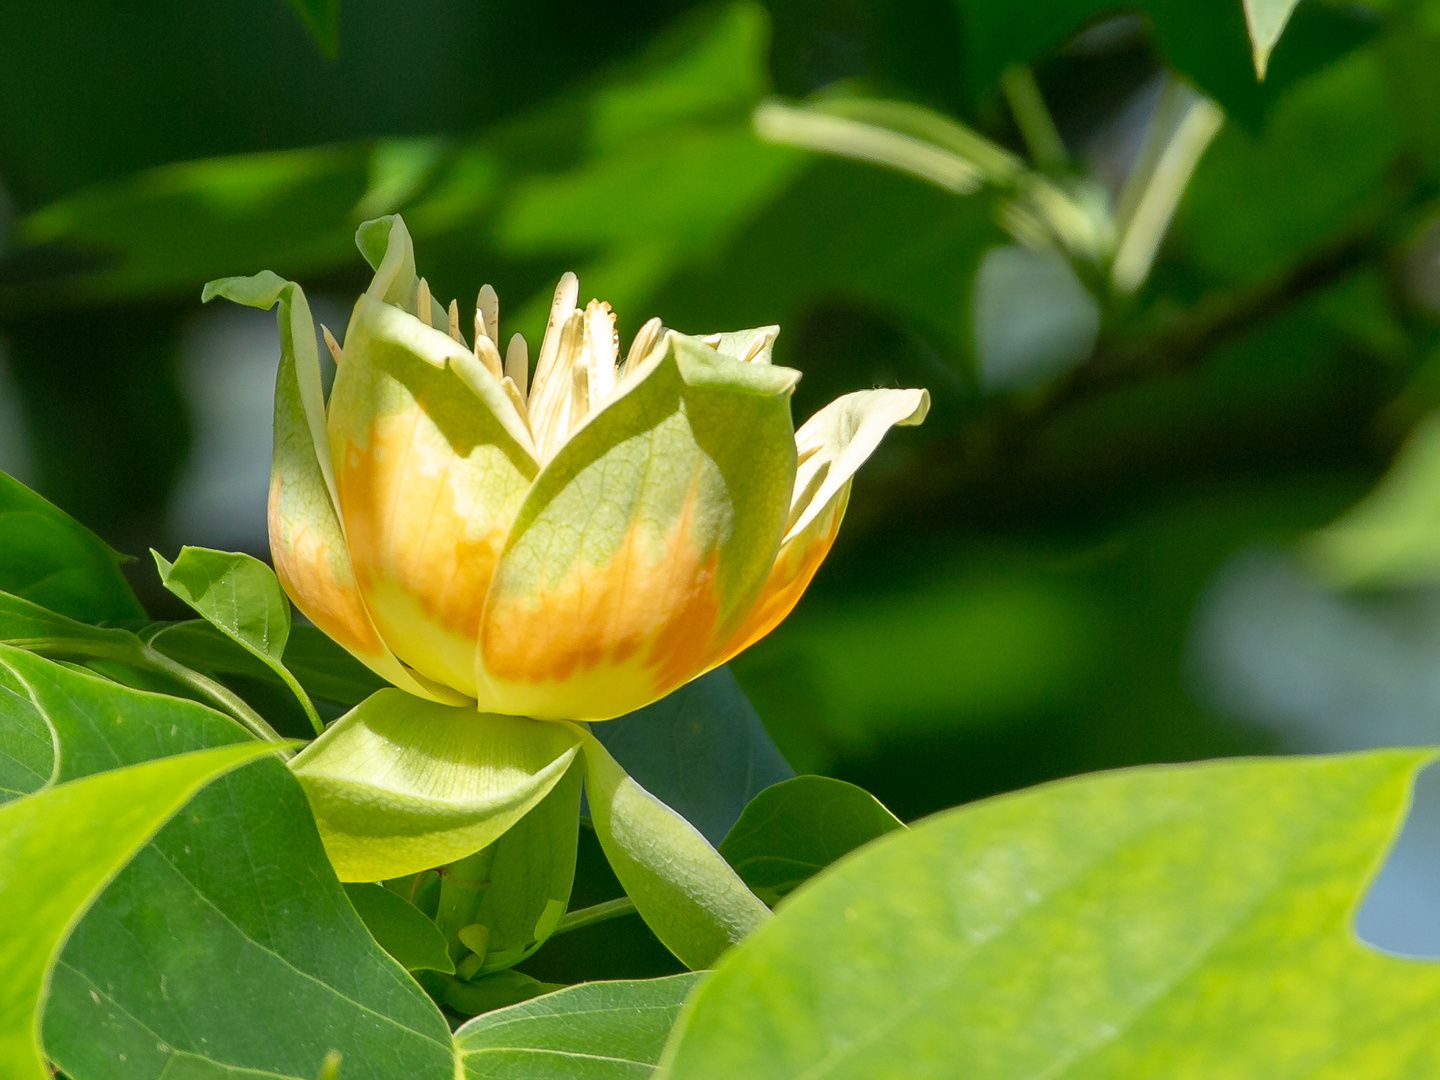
<box><xmin>330</xmin><ymin>295</ymin><xmax>539</xmax><ymax>696</ymax></box>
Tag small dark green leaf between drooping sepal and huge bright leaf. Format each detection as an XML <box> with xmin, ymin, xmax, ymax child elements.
<box><xmin>720</xmin><ymin>776</ymin><xmax>904</xmax><ymax>907</ymax></box>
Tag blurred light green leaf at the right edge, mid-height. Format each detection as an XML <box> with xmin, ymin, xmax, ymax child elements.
<box><xmin>1308</xmin><ymin>416</ymin><xmax>1440</xmax><ymax>586</ymax></box>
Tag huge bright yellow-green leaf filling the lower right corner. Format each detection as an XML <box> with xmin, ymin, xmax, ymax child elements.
<box><xmin>661</xmin><ymin>750</ymin><xmax>1440</xmax><ymax>1080</ymax></box>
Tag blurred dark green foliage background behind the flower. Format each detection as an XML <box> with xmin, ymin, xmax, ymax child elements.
<box><xmin>0</xmin><ymin>0</ymin><xmax>1440</xmax><ymax>955</ymax></box>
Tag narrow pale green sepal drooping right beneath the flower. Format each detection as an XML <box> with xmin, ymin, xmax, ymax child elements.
<box><xmin>585</xmin><ymin>736</ymin><xmax>769</xmax><ymax>971</ymax></box>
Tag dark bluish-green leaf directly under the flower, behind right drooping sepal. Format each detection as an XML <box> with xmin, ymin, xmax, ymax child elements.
<box><xmin>590</xmin><ymin>667</ymin><xmax>795</xmax><ymax>844</ymax></box>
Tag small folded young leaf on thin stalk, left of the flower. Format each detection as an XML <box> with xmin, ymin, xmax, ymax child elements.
<box><xmin>150</xmin><ymin>547</ymin><xmax>324</xmax><ymax>734</ymax></box>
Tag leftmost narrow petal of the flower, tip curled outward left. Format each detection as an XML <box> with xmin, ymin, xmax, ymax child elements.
<box><xmin>204</xmin><ymin>271</ymin><xmax>461</xmax><ymax>701</ymax></box>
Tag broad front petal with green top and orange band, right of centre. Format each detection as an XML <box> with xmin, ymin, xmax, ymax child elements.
<box><xmin>477</xmin><ymin>333</ymin><xmax>799</xmax><ymax>720</ymax></box>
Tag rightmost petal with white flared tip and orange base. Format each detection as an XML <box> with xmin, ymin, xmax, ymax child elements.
<box><xmin>711</xmin><ymin>390</ymin><xmax>930</xmax><ymax>664</ymax></box>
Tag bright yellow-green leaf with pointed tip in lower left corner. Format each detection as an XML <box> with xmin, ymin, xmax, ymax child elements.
<box><xmin>0</xmin><ymin>743</ymin><xmax>269</xmax><ymax>1080</ymax></box>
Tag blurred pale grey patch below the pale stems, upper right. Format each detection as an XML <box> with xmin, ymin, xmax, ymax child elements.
<box><xmin>972</xmin><ymin>243</ymin><xmax>1100</xmax><ymax>390</ymax></box>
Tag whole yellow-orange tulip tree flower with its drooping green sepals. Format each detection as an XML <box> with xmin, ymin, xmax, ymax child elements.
<box><xmin>206</xmin><ymin>216</ymin><xmax>929</xmax><ymax>966</ymax></box>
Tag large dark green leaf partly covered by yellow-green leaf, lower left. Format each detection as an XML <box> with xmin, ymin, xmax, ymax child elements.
<box><xmin>0</xmin><ymin>648</ymin><xmax>452</xmax><ymax>1080</ymax></box>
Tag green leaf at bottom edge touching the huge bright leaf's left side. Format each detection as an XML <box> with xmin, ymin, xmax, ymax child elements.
<box><xmin>455</xmin><ymin>973</ymin><xmax>701</xmax><ymax>1080</ymax></box>
